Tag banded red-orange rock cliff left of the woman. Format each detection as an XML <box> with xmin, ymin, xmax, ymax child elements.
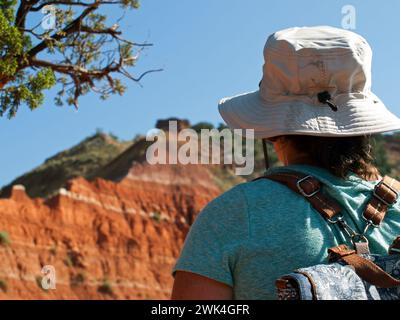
<box><xmin>0</xmin><ymin>164</ymin><xmax>220</xmax><ymax>299</ymax></box>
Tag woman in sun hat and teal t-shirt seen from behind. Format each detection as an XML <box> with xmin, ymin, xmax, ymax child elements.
<box><xmin>172</xmin><ymin>27</ymin><xmax>400</xmax><ymax>299</ymax></box>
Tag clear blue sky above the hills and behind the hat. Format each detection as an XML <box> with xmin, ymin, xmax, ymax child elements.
<box><xmin>0</xmin><ymin>0</ymin><xmax>400</xmax><ymax>186</ymax></box>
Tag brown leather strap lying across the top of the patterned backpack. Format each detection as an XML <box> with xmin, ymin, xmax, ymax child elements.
<box><xmin>328</xmin><ymin>244</ymin><xmax>400</xmax><ymax>288</ymax></box>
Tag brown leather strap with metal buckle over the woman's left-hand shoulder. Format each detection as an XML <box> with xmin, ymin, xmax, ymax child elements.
<box><xmin>256</xmin><ymin>171</ymin><xmax>341</xmax><ymax>219</ymax></box>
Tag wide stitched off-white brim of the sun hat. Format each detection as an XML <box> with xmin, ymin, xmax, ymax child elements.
<box><xmin>218</xmin><ymin>90</ymin><xmax>400</xmax><ymax>138</ymax></box>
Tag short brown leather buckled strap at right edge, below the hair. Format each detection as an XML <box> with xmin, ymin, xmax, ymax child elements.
<box><xmin>363</xmin><ymin>176</ymin><xmax>400</xmax><ymax>226</ymax></box>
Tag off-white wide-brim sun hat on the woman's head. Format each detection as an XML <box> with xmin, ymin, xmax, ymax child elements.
<box><xmin>219</xmin><ymin>26</ymin><xmax>400</xmax><ymax>138</ymax></box>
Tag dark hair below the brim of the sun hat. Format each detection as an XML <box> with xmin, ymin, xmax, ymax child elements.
<box><xmin>285</xmin><ymin>135</ymin><xmax>379</xmax><ymax>180</ymax></box>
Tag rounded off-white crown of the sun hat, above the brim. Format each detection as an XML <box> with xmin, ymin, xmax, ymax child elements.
<box><xmin>260</xmin><ymin>26</ymin><xmax>372</xmax><ymax>102</ymax></box>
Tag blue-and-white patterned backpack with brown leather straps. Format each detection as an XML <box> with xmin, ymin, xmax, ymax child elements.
<box><xmin>258</xmin><ymin>171</ymin><xmax>400</xmax><ymax>300</ymax></box>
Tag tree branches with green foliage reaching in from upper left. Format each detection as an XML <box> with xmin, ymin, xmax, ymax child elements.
<box><xmin>0</xmin><ymin>0</ymin><xmax>159</xmax><ymax>118</ymax></box>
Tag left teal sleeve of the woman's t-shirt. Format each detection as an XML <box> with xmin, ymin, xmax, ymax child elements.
<box><xmin>172</xmin><ymin>185</ymin><xmax>249</xmax><ymax>287</ymax></box>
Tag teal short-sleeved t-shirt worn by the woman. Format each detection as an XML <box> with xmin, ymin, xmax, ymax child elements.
<box><xmin>173</xmin><ymin>165</ymin><xmax>400</xmax><ymax>299</ymax></box>
